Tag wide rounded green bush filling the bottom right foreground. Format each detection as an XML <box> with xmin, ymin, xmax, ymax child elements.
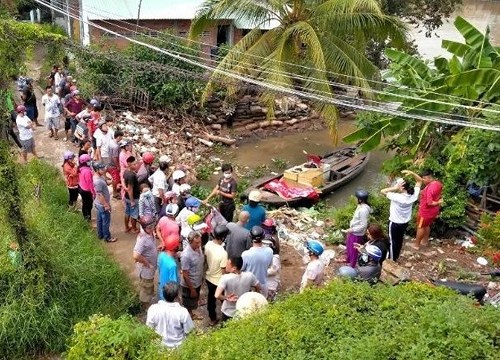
<box><xmin>169</xmin><ymin>281</ymin><xmax>500</xmax><ymax>360</ymax></box>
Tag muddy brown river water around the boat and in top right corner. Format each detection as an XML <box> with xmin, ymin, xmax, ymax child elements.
<box><xmin>224</xmin><ymin>0</ymin><xmax>500</xmax><ymax>206</ymax></box>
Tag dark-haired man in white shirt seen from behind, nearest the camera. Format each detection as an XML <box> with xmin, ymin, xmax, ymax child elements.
<box><xmin>146</xmin><ymin>281</ymin><xmax>194</xmax><ymax>348</ymax></box>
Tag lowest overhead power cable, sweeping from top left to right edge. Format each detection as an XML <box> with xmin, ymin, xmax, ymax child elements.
<box><xmin>36</xmin><ymin>0</ymin><xmax>500</xmax><ymax>131</ymax></box>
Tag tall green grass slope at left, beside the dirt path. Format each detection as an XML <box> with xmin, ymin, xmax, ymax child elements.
<box><xmin>0</xmin><ymin>161</ymin><xmax>138</xmax><ymax>359</ymax></box>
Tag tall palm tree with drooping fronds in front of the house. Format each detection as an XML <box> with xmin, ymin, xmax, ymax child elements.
<box><xmin>189</xmin><ymin>0</ymin><xmax>406</xmax><ymax>139</ymax></box>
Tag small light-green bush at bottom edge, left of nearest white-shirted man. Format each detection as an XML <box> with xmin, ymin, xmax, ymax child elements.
<box><xmin>65</xmin><ymin>315</ymin><xmax>166</xmax><ymax>360</ymax></box>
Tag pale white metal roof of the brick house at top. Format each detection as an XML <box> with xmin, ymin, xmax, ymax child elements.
<box><xmin>81</xmin><ymin>0</ymin><xmax>205</xmax><ymax>20</ymax></box>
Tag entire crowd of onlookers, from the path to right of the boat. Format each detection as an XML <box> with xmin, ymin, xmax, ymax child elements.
<box><xmin>7</xmin><ymin>66</ymin><xmax>443</xmax><ymax>347</ymax></box>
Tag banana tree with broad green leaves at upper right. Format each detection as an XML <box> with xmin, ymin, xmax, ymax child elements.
<box><xmin>344</xmin><ymin>17</ymin><xmax>500</xmax><ymax>155</ymax></box>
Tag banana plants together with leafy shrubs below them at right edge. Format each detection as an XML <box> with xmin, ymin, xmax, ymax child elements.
<box><xmin>344</xmin><ymin>17</ymin><xmax>500</xmax><ymax>227</ymax></box>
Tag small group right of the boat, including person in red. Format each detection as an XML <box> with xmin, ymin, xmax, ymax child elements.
<box><xmin>338</xmin><ymin>170</ymin><xmax>443</xmax><ymax>283</ymax></box>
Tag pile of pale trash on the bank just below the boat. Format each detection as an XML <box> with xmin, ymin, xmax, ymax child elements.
<box><xmin>268</xmin><ymin>207</ymin><xmax>336</xmax><ymax>265</ymax></box>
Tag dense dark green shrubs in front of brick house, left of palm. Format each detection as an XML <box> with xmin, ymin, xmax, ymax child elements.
<box><xmin>72</xmin><ymin>32</ymin><xmax>203</xmax><ymax>110</ymax></box>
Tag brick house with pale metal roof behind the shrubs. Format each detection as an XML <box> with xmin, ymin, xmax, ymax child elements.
<box><xmin>63</xmin><ymin>0</ymin><xmax>274</xmax><ymax>54</ymax></box>
